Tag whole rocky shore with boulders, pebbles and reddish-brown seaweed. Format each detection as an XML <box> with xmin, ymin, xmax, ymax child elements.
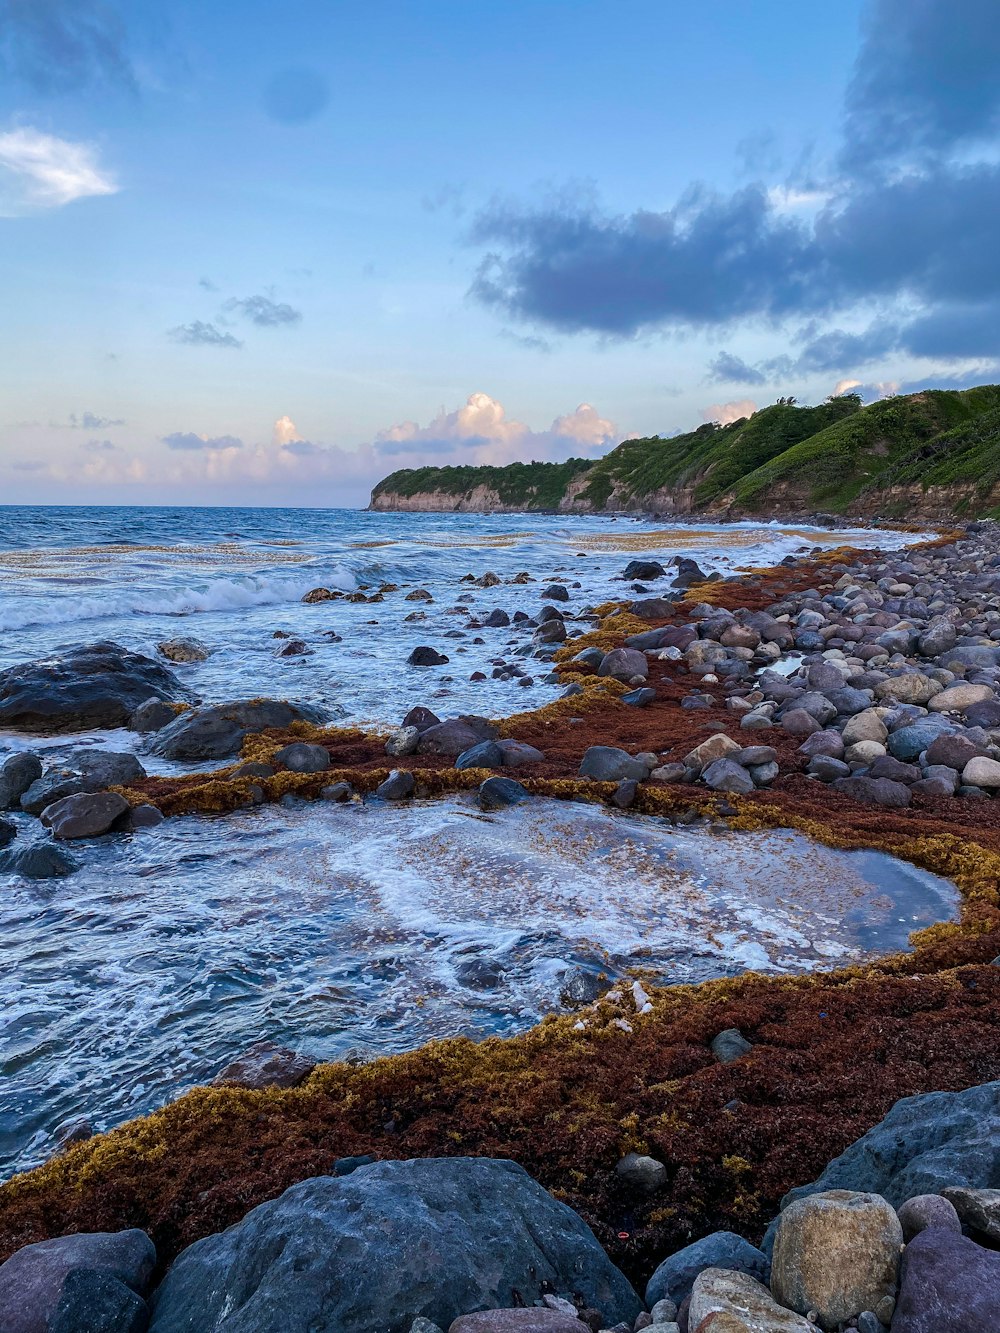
<box><xmin>0</xmin><ymin>524</ymin><xmax>1000</xmax><ymax>1333</ymax></box>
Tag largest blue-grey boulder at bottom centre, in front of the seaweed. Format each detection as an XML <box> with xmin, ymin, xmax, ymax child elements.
<box><xmin>144</xmin><ymin>1157</ymin><xmax>641</xmax><ymax>1333</ymax></box>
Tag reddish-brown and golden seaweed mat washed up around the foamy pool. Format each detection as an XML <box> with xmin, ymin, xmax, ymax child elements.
<box><xmin>0</xmin><ymin>517</ymin><xmax>1000</xmax><ymax>1273</ymax></box>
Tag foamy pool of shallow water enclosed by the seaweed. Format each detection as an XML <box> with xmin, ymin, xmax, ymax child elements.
<box><xmin>0</xmin><ymin>797</ymin><xmax>956</xmax><ymax>1170</ymax></box>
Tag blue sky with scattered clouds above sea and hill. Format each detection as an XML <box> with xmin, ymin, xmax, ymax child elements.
<box><xmin>0</xmin><ymin>0</ymin><xmax>1000</xmax><ymax>507</ymax></box>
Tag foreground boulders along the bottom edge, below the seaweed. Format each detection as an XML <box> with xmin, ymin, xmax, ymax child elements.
<box><xmin>0</xmin><ymin>1082</ymin><xmax>1000</xmax><ymax>1333</ymax></box>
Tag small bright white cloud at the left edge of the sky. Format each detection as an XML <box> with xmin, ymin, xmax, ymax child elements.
<box><xmin>0</xmin><ymin>125</ymin><xmax>120</xmax><ymax>217</ymax></box>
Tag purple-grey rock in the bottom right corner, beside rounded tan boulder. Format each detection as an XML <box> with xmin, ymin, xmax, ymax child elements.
<box><xmin>892</xmin><ymin>1226</ymin><xmax>1000</xmax><ymax>1333</ymax></box>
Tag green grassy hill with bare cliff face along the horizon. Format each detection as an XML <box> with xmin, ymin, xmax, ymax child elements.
<box><xmin>372</xmin><ymin>385</ymin><xmax>1000</xmax><ymax>517</ymax></box>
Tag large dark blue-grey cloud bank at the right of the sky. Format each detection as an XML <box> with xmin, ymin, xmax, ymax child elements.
<box><xmin>471</xmin><ymin>0</ymin><xmax>1000</xmax><ymax>384</ymax></box>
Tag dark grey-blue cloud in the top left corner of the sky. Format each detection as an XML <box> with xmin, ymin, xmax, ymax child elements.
<box><xmin>0</xmin><ymin>0</ymin><xmax>135</xmax><ymax>93</ymax></box>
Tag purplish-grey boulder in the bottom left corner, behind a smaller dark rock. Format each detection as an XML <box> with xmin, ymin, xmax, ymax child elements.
<box><xmin>0</xmin><ymin>1230</ymin><xmax>156</xmax><ymax>1333</ymax></box>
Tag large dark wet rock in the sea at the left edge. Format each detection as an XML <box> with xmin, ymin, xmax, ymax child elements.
<box><xmin>0</xmin><ymin>643</ymin><xmax>187</xmax><ymax>733</ymax></box>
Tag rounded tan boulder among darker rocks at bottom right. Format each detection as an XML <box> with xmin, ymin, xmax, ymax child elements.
<box><xmin>771</xmin><ymin>1189</ymin><xmax>903</xmax><ymax>1329</ymax></box>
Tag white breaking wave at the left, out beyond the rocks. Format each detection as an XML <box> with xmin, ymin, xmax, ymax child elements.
<box><xmin>0</xmin><ymin>565</ymin><xmax>357</xmax><ymax>632</ymax></box>
